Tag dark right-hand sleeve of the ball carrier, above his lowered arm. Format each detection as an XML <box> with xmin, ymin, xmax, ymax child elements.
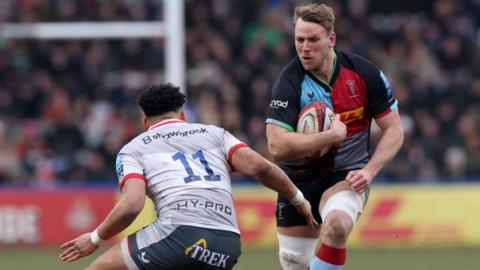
<box><xmin>367</xmin><ymin>67</ymin><xmax>398</xmax><ymax>118</ymax></box>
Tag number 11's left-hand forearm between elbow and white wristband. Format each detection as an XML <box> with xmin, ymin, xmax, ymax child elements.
<box><xmin>98</xmin><ymin>197</ymin><xmax>141</xmax><ymax>240</ymax></box>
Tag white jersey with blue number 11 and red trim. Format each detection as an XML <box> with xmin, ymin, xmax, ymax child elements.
<box><xmin>116</xmin><ymin>119</ymin><xmax>246</xmax><ymax>233</ymax></box>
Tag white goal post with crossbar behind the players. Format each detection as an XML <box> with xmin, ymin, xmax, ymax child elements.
<box><xmin>0</xmin><ymin>0</ymin><xmax>186</xmax><ymax>92</ymax></box>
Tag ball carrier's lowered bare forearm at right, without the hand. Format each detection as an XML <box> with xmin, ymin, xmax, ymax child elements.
<box><xmin>365</xmin><ymin>126</ymin><xmax>404</xmax><ymax>177</ymax></box>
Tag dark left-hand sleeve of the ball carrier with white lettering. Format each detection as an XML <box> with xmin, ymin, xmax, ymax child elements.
<box><xmin>265</xmin><ymin>59</ymin><xmax>301</xmax><ymax>131</ymax></box>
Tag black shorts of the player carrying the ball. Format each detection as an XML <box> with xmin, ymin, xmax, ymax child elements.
<box><xmin>275</xmin><ymin>170</ymin><xmax>350</xmax><ymax>227</ymax></box>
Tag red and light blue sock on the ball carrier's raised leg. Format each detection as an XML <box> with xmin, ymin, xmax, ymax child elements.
<box><xmin>310</xmin><ymin>243</ymin><xmax>346</xmax><ymax>270</ymax></box>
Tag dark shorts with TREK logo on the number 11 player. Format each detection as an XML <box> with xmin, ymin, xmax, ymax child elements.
<box><xmin>122</xmin><ymin>225</ymin><xmax>240</xmax><ymax>270</ymax></box>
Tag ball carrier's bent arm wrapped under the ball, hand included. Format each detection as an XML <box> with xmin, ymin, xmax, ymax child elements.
<box><xmin>266</xmin><ymin>114</ymin><xmax>347</xmax><ymax>161</ymax></box>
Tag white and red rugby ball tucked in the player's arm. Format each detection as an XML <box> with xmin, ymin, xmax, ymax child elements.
<box><xmin>297</xmin><ymin>101</ymin><xmax>335</xmax><ymax>157</ymax></box>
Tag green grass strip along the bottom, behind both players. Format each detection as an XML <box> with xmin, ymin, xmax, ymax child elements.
<box><xmin>0</xmin><ymin>247</ymin><xmax>480</xmax><ymax>270</ymax></box>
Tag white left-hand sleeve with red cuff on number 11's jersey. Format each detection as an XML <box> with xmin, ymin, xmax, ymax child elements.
<box><xmin>115</xmin><ymin>152</ymin><xmax>147</xmax><ymax>189</ymax></box>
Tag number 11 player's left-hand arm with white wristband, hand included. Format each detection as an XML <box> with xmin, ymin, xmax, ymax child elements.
<box><xmin>59</xmin><ymin>178</ymin><xmax>145</xmax><ymax>262</ymax></box>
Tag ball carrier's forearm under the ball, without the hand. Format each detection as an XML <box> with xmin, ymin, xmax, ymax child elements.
<box><xmin>268</xmin><ymin>131</ymin><xmax>336</xmax><ymax>162</ymax></box>
